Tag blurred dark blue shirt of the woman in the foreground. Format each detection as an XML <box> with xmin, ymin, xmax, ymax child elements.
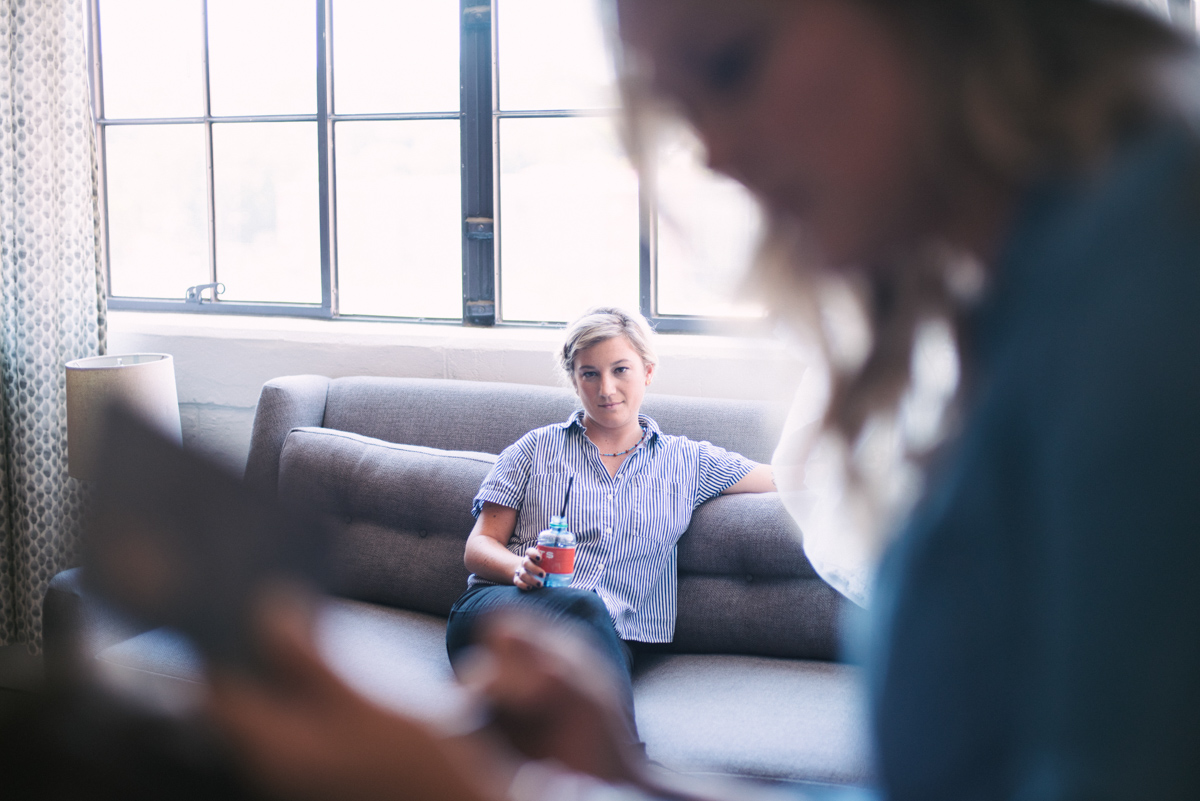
<box><xmin>870</xmin><ymin>125</ymin><xmax>1200</xmax><ymax>801</ymax></box>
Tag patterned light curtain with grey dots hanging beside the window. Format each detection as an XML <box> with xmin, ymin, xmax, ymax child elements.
<box><xmin>0</xmin><ymin>0</ymin><xmax>106</xmax><ymax>650</ymax></box>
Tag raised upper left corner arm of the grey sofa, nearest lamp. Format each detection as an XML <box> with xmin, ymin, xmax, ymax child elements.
<box><xmin>246</xmin><ymin>375</ymin><xmax>329</xmax><ymax>495</ymax></box>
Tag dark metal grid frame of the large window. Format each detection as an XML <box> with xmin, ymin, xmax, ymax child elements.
<box><xmin>88</xmin><ymin>0</ymin><xmax>764</xmax><ymax>335</ymax></box>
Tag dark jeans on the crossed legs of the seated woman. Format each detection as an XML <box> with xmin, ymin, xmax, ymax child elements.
<box><xmin>446</xmin><ymin>584</ymin><xmax>638</xmax><ymax>743</ymax></box>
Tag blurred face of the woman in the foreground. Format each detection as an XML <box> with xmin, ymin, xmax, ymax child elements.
<box><xmin>617</xmin><ymin>0</ymin><xmax>932</xmax><ymax>266</ymax></box>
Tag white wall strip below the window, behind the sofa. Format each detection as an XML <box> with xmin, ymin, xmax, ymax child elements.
<box><xmin>108</xmin><ymin>312</ymin><xmax>803</xmax><ymax>470</ymax></box>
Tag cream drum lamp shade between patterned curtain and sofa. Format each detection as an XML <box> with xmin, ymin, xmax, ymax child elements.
<box><xmin>67</xmin><ymin>354</ymin><xmax>184</xmax><ymax>480</ymax></box>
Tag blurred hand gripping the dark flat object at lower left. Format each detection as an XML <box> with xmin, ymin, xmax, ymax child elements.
<box><xmin>209</xmin><ymin>587</ymin><xmax>516</xmax><ymax>801</ymax></box>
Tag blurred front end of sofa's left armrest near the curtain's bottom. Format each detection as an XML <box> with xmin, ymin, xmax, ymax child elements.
<box><xmin>42</xmin><ymin>567</ymin><xmax>151</xmax><ymax>681</ymax></box>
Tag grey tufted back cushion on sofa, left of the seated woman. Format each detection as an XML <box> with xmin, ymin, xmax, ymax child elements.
<box><xmin>280</xmin><ymin>428</ymin><xmax>496</xmax><ymax>615</ymax></box>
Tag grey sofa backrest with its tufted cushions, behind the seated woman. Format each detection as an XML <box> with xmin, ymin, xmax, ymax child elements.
<box><xmin>254</xmin><ymin>377</ymin><xmax>844</xmax><ymax>658</ymax></box>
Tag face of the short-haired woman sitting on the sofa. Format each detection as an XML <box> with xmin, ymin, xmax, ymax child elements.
<box><xmin>571</xmin><ymin>336</ymin><xmax>654</xmax><ymax>432</ymax></box>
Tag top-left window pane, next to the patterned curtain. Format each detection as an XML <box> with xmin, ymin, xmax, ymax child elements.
<box><xmin>100</xmin><ymin>0</ymin><xmax>204</xmax><ymax>119</ymax></box>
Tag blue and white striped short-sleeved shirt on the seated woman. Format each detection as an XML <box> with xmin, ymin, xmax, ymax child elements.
<box><xmin>468</xmin><ymin>411</ymin><xmax>756</xmax><ymax>643</ymax></box>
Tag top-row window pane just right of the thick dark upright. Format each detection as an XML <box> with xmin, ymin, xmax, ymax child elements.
<box><xmin>496</xmin><ymin>0</ymin><xmax>617</xmax><ymax>109</ymax></box>
